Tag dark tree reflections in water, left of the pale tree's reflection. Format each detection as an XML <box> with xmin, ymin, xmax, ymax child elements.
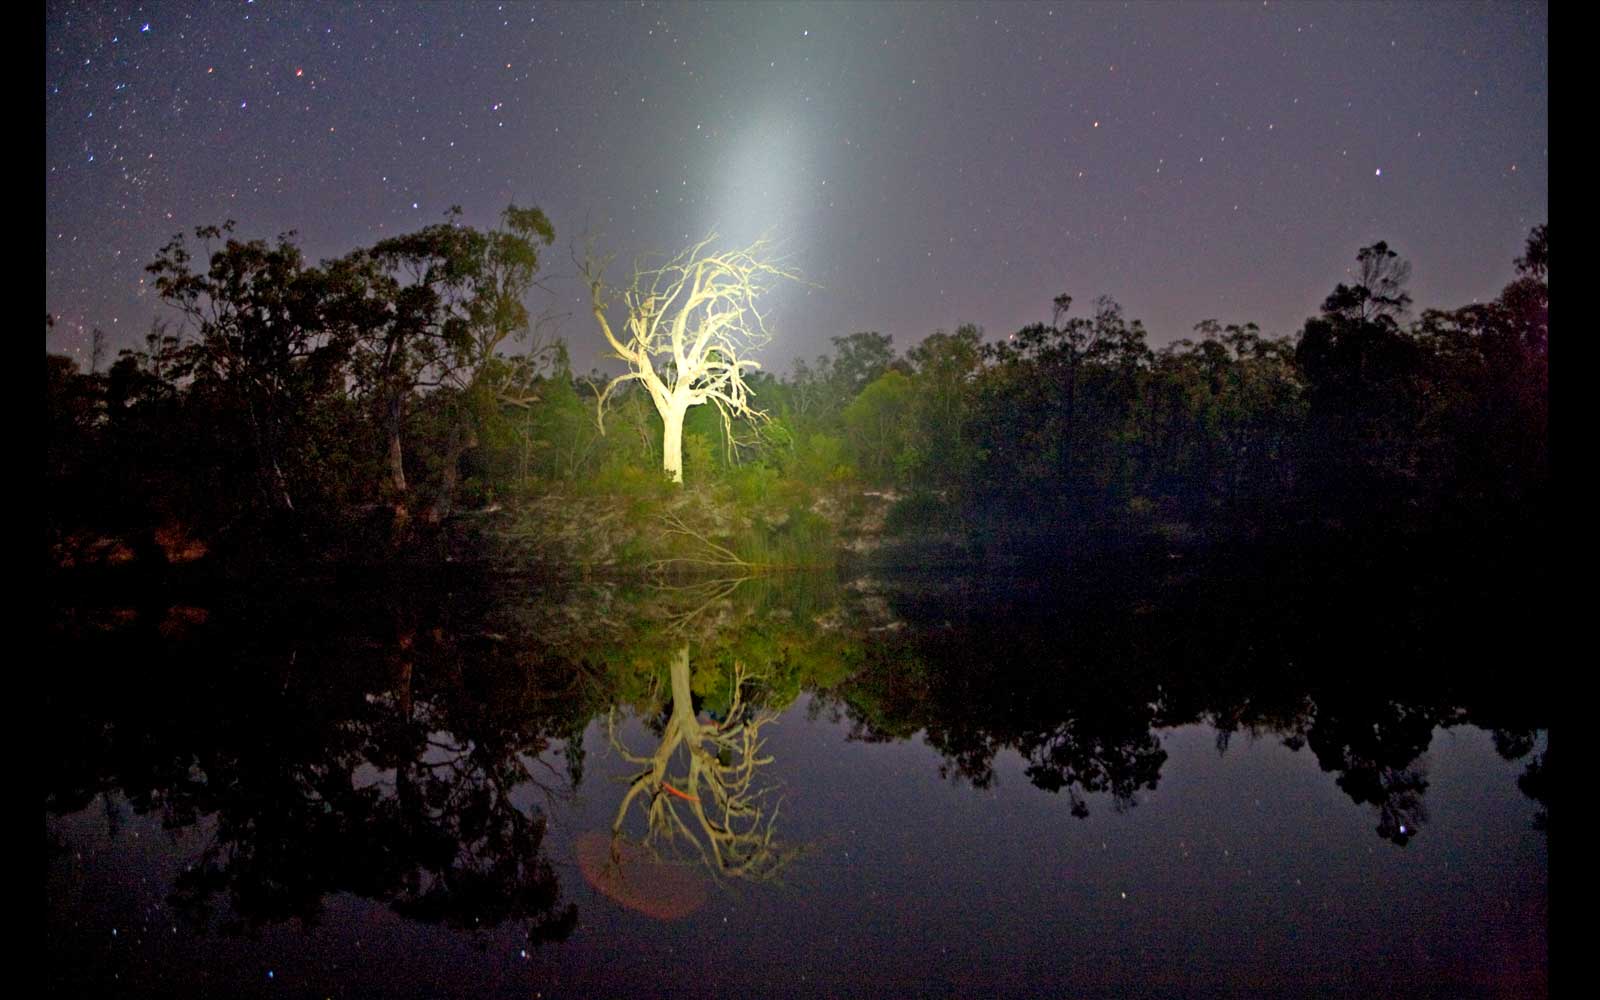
<box><xmin>46</xmin><ymin>576</ymin><xmax>582</xmax><ymax>944</ymax></box>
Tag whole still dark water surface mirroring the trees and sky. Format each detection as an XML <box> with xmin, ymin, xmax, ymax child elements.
<box><xmin>43</xmin><ymin>550</ymin><xmax>1549</xmax><ymax>997</ymax></box>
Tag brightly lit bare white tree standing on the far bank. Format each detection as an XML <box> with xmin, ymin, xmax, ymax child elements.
<box><xmin>582</xmin><ymin>234</ymin><xmax>797</xmax><ymax>483</ymax></box>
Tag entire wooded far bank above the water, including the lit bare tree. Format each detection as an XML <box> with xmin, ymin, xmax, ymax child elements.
<box><xmin>45</xmin><ymin>214</ymin><xmax>1549</xmax><ymax>573</ymax></box>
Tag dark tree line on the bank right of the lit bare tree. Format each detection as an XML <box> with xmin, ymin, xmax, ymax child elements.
<box><xmin>811</xmin><ymin>226</ymin><xmax>1549</xmax><ymax>541</ymax></box>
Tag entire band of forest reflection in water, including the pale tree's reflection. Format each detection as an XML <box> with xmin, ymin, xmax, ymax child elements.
<box><xmin>43</xmin><ymin>537</ymin><xmax>1549</xmax><ymax>941</ymax></box>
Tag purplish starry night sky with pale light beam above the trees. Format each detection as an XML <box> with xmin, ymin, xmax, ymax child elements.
<box><xmin>45</xmin><ymin>0</ymin><xmax>1549</xmax><ymax>371</ymax></box>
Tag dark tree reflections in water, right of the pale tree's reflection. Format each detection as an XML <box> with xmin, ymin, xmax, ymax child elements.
<box><xmin>827</xmin><ymin>531</ymin><xmax>1550</xmax><ymax>845</ymax></box>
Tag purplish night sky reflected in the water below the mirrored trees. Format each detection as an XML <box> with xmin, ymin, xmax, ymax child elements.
<box><xmin>46</xmin><ymin>698</ymin><xmax>1547</xmax><ymax>997</ymax></box>
